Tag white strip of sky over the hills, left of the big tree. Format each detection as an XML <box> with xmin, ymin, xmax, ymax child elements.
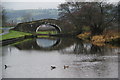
<box><xmin>2</xmin><ymin>2</ymin><xmax>63</xmax><ymax>10</ymax></box>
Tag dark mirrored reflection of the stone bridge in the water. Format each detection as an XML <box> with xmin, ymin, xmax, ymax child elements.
<box><xmin>15</xmin><ymin>38</ymin><xmax>74</xmax><ymax>51</ymax></box>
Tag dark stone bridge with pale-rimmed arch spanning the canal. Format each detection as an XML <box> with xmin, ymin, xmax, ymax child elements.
<box><xmin>14</xmin><ymin>19</ymin><xmax>74</xmax><ymax>33</ymax></box>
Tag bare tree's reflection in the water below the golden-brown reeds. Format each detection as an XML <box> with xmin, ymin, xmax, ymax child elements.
<box><xmin>61</xmin><ymin>42</ymin><xmax>106</xmax><ymax>55</ymax></box>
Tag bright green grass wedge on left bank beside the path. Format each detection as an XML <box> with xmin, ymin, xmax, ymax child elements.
<box><xmin>0</xmin><ymin>30</ymin><xmax>32</xmax><ymax>40</ymax></box>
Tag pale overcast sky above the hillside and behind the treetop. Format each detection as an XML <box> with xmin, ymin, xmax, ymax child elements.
<box><xmin>2</xmin><ymin>0</ymin><xmax>119</xmax><ymax>10</ymax></box>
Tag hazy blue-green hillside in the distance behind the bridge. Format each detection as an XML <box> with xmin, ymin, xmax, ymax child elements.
<box><xmin>6</xmin><ymin>9</ymin><xmax>58</xmax><ymax>22</ymax></box>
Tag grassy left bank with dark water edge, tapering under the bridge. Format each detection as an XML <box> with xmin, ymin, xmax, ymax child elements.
<box><xmin>0</xmin><ymin>30</ymin><xmax>58</xmax><ymax>46</ymax></box>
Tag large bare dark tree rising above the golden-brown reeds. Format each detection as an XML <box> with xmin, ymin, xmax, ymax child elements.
<box><xmin>59</xmin><ymin>1</ymin><xmax>117</xmax><ymax>35</ymax></box>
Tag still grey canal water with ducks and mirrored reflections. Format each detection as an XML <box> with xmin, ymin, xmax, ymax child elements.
<box><xmin>2</xmin><ymin>38</ymin><xmax>119</xmax><ymax>78</ymax></box>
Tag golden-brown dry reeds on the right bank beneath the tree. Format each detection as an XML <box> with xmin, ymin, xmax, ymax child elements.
<box><xmin>77</xmin><ymin>32</ymin><xmax>120</xmax><ymax>46</ymax></box>
